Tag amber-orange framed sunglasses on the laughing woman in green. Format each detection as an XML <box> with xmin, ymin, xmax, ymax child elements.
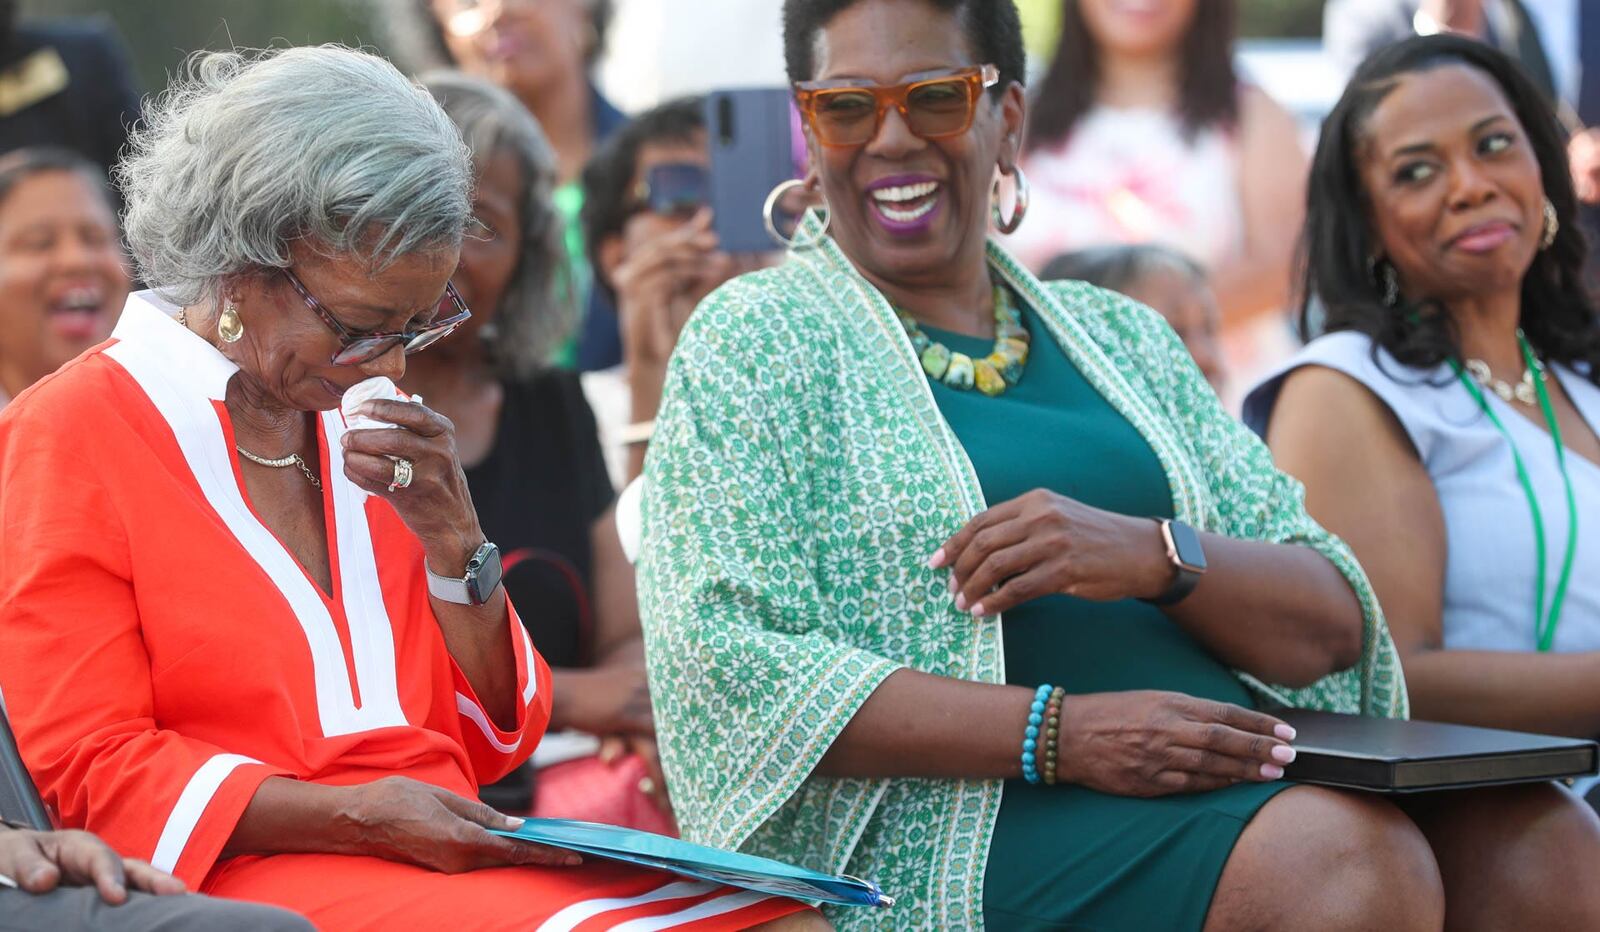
<box><xmin>795</xmin><ymin>64</ymin><xmax>1000</xmax><ymax>147</ymax></box>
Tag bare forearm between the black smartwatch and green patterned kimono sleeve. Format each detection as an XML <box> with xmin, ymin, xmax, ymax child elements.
<box><xmin>1168</xmin><ymin>533</ymin><xmax>1363</xmax><ymax>687</ymax></box>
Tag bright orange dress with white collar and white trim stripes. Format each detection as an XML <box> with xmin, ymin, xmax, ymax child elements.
<box><xmin>0</xmin><ymin>293</ymin><xmax>803</xmax><ymax>929</ymax></box>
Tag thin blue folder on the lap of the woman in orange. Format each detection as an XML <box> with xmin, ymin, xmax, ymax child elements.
<box><xmin>490</xmin><ymin>818</ymin><xmax>894</xmax><ymax>906</ymax></box>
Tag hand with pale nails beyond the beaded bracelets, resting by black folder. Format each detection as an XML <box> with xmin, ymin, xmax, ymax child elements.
<box><xmin>1056</xmin><ymin>690</ymin><xmax>1294</xmax><ymax>796</ymax></box>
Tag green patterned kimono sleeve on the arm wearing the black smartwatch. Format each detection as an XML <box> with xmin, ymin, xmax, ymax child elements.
<box><xmin>1053</xmin><ymin>283</ymin><xmax>1408</xmax><ymax>717</ymax></box>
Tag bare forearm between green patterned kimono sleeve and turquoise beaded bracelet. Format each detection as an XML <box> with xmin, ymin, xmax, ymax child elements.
<box><xmin>816</xmin><ymin>669</ymin><xmax>1034</xmax><ymax>780</ymax></box>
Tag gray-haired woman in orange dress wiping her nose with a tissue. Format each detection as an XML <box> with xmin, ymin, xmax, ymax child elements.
<box><xmin>0</xmin><ymin>46</ymin><xmax>814</xmax><ymax>929</ymax></box>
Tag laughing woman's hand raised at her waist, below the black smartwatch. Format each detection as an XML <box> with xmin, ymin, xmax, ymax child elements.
<box><xmin>928</xmin><ymin>488</ymin><xmax>1173</xmax><ymax>615</ymax></box>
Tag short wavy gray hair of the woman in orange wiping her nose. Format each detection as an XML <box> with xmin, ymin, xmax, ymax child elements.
<box><xmin>115</xmin><ymin>45</ymin><xmax>472</xmax><ymax>304</ymax></box>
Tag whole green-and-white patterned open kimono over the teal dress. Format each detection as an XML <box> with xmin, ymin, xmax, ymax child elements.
<box><xmin>638</xmin><ymin>230</ymin><xmax>1406</xmax><ymax>929</ymax></box>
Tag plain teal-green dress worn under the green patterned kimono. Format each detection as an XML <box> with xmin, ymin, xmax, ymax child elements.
<box><xmin>928</xmin><ymin>302</ymin><xmax>1285</xmax><ymax>930</ymax></box>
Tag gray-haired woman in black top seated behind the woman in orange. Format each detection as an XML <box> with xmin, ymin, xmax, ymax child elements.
<box><xmin>403</xmin><ymin>72</ymin><xmax>674</xmax><ymax>831</ymax></box>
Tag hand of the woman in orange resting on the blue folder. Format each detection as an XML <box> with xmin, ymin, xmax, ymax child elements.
<box><xmin>338</xmin><ymin>777</ymin><xmax>582</xmax><ymax>874</ymax></box>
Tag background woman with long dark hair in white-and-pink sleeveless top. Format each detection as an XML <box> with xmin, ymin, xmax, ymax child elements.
<box><xmin>1008</xmin><ymin>0</ymin><xmax>1306</xmax><ymax>393</ymax></box>
